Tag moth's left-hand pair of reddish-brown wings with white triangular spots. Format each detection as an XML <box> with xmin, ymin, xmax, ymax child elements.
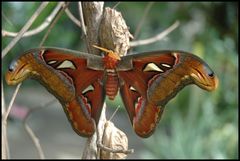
<box><xmin>6</xmin><ymin>48</ymin><xmax>105</xmax><ymax>136</ymax></box>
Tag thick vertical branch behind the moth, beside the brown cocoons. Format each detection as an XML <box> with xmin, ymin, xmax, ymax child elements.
<box><xmin>79</xmin><ymin>2</ymin><xmax>103</xmax><ymax>159</ymax></box>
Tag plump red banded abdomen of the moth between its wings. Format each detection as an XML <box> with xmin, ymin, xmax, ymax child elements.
<box><xmin>105</xmin><ymin>70</ymin><xmax>119</xmax><ymax>100</ymax></box>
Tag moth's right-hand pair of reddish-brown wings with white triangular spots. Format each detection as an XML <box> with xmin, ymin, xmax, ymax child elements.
<box><xmin>118</xmin><ymin>51</ymin><xmax>218</xmax><ymax>137</ymax></box>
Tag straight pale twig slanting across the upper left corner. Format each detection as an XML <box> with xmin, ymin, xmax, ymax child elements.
<box><xmin>2</xmin><ymin>2</ymin><xmax>49</xmax><ymax>59</ymax></box>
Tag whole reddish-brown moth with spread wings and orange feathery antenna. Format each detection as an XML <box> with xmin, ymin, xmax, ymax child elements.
<box><xmin>6</xmin><ymin>47</ymin><xmax>218</xmax><ymax>137</ymax></box>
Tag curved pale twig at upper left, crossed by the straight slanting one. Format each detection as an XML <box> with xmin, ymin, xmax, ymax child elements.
<box><xmin>2</xmin><ymin>2</ymin><xmax>64</xmax><ymax>37</ymax></box>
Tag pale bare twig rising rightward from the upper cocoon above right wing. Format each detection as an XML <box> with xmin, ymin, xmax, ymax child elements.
<box><xmin>130</xmin><ymin>21</ymin><xmax>179</xmax><ymax>47</ymax></box>
